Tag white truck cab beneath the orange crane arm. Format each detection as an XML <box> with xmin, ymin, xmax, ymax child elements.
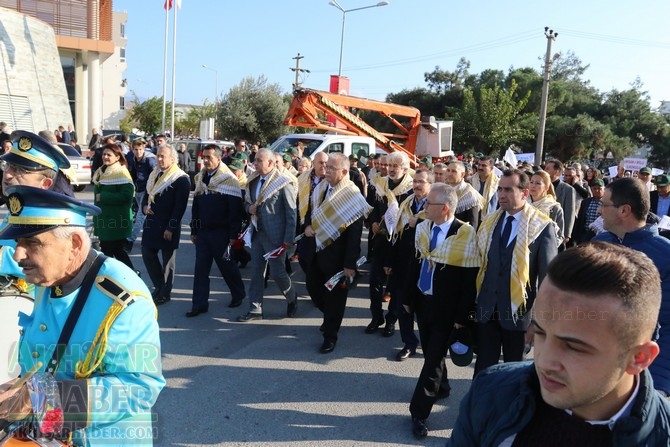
<box><xmin>269</xmin><ymin>133</ymin><xmax>376</xmax><ymax>160</ymax></box>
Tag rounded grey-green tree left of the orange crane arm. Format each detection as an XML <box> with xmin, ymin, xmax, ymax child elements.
<box><xmin>216</xmin><ymin>75</ymin><xmax>288</xmax><ymax>143</ymax></box>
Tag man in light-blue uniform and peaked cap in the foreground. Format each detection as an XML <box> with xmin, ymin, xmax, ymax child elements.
<box><xmin>0</xmin><ymin>186</ymin><xmax>165</xmax><ymax>446</ymax></box>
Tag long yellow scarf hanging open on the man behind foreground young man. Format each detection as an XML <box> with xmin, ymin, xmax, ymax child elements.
<box><xmin>477</xmin><ymin>204</ymin><xmax>552</xmax><ymax>323</ymax></box>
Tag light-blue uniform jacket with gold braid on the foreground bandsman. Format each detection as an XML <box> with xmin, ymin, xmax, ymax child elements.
<box><xmin>0</xmin><ymin>247</ymin><xmax>165</xmax><ymax>446</ymax></box>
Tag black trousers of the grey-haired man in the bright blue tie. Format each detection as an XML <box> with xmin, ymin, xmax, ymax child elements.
<box><xmin>409</xmin><ymin>296</ymin><xmax>454</xmax><ymax>419</ymax></box>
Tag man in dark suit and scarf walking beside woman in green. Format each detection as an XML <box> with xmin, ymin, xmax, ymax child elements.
<box><xmin>142</xmin><ymin>145</ymin><xmax>191</xmax><ymax>305</ymax></box>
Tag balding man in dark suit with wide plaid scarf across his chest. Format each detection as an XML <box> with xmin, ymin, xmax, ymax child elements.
<box><xmin>305</xmin><ymin>153</ymin><xmax>372</xmax><ymax>354</ymax></box>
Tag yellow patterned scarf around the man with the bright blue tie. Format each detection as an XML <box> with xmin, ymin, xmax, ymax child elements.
<box><xmin>414</xmin><ymin>220</ymin><xmax>481</xmax><ymax>267</ymax></box>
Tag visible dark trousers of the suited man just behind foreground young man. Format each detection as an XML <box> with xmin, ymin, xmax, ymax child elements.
<box><xmin>474</xmin><ymin>319</ymin><xmax>526</xmax><ymax>376</ymax></box>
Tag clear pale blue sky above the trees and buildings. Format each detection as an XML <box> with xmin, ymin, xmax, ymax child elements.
<box><xmin>114</xmin><ymin>0</ymin><xmax>670</xmax><ymax>108</ymax></box>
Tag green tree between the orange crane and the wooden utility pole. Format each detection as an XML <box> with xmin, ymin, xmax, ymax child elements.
<box><xmin>454</xmin><ymin>82</ymin><xmax>528</xmax><ymax>155</ymax></box>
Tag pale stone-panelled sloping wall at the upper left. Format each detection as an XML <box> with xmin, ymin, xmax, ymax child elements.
<box><xmin>0</xmin><ymin>8</ymin><xmax>72</xmax><ymax>132</ymax></box>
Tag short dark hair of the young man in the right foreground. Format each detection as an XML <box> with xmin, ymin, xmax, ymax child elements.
<box><xmin>547</xmin><ymin>243</ymin><xmax>661</xmax><ymax>349</ymax></box>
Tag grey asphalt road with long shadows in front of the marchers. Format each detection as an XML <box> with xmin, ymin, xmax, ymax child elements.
<box><xmin>77</xmin><ymin>187</ymin><xmax>484</xmax><ymax>446</ymax></box>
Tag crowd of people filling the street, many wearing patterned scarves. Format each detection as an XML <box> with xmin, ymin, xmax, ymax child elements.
<box><xmin>0</xmin><ymin>128</ymin><xmax>670</xmax><ymax>446</ymax></box>
